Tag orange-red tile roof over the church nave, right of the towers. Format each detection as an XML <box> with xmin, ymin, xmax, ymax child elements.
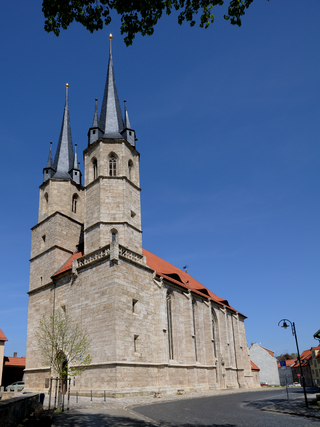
<box><xmin>142</xmin><ymin>249</ymin><xmax>242</xmax><ymax>312</ymax></box>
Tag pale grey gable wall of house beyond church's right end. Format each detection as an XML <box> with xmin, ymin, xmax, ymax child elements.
<box><xmin>250</xmin><ymin>343</ymin><xmax>280</xmax><ymax>385</ymax></box>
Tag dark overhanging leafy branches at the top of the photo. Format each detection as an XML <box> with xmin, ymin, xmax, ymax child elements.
<box><xmin>42</xmin><ymin>0</ymin><xmax>264</xmax><ymax>46</ymax></box>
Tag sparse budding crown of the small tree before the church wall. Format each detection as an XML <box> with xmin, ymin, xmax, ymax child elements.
<box><xmin>36</xmin><ymin>309</ymin><xmax>91</xmax><ymax>377</ymax></box>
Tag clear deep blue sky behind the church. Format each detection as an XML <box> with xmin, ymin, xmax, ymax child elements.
<box><xmin>0</xmin><ymin>0</ymin><xmax>320</xmax><ymax>356</ymax></box>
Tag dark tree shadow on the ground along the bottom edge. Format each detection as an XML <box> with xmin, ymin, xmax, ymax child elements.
<box><xmin>52</xmin><ymin>411</ymin><xmax>236</xmax><ymax>427</ymax></box>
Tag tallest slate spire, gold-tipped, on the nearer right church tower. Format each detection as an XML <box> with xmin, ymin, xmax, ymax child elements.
<box><xmin>100</xmin><ymin>34</ymin><xmax>123</xmax><ymax>138</ymax></box>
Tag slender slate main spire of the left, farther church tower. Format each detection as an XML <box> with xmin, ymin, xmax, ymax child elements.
<box><xmin>53</xmin><ymin>83</ymin><xmax>73</xmax><ymax>178</ymax></box>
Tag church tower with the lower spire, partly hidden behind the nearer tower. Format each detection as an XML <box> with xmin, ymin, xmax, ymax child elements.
<box><xmin>30</xmin><ymin>84</ymin><xmax>83</xmax><ymax>290</ymax></box>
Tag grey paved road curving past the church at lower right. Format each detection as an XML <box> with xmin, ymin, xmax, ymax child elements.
<box><xmin>133</xmin><ymin>388</ymin><xmax>320</xmax><ymax>427</ymax></box>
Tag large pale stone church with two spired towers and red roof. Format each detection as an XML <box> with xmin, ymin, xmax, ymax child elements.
<box><xmin>25</xmin><ymin>36</ymin><xmax>256</xmax><ymax>397</ymax></box>
